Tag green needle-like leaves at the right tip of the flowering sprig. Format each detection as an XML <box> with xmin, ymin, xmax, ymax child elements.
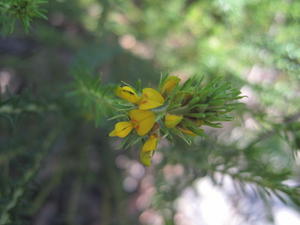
<box><xmin>170</xmin><ymin>76</ymin><xmax>244</xmax><ymax>127</ymax></box>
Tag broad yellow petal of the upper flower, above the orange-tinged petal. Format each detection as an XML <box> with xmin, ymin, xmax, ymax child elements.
<box><xmin>138</xmin><ymin>88</ymin><xmax>165</xmax><ymax>110</ymax></box>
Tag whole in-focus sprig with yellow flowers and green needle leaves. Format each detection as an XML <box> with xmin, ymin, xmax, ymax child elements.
<box><xmin>109</xmin><ymin>76</ymin><xmax>241</xmax><ymax>166</ymax></box>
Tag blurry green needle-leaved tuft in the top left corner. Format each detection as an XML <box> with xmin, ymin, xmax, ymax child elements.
<box><xmin>0</xmin><ymin>0</ymin><xmax>48</xmax><ymax>34</ymax></box>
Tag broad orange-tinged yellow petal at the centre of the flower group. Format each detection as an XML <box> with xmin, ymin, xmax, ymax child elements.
<box><xmin>129</xmin><ymin>109</ymin><xmax>155</xmax><ymax>136</ymax></box>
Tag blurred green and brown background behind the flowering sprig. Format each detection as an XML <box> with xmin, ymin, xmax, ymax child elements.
<box><xmin>0</xmin><ymin>0</ymin><xmax>300</xmax><ymax>225</ymax></box>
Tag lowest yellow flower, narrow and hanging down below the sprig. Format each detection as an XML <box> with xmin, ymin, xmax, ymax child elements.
<box><xmin>140</xmin><ymin>134</ymin><xmax>158</xmax><ymax>166</ymax></box>
